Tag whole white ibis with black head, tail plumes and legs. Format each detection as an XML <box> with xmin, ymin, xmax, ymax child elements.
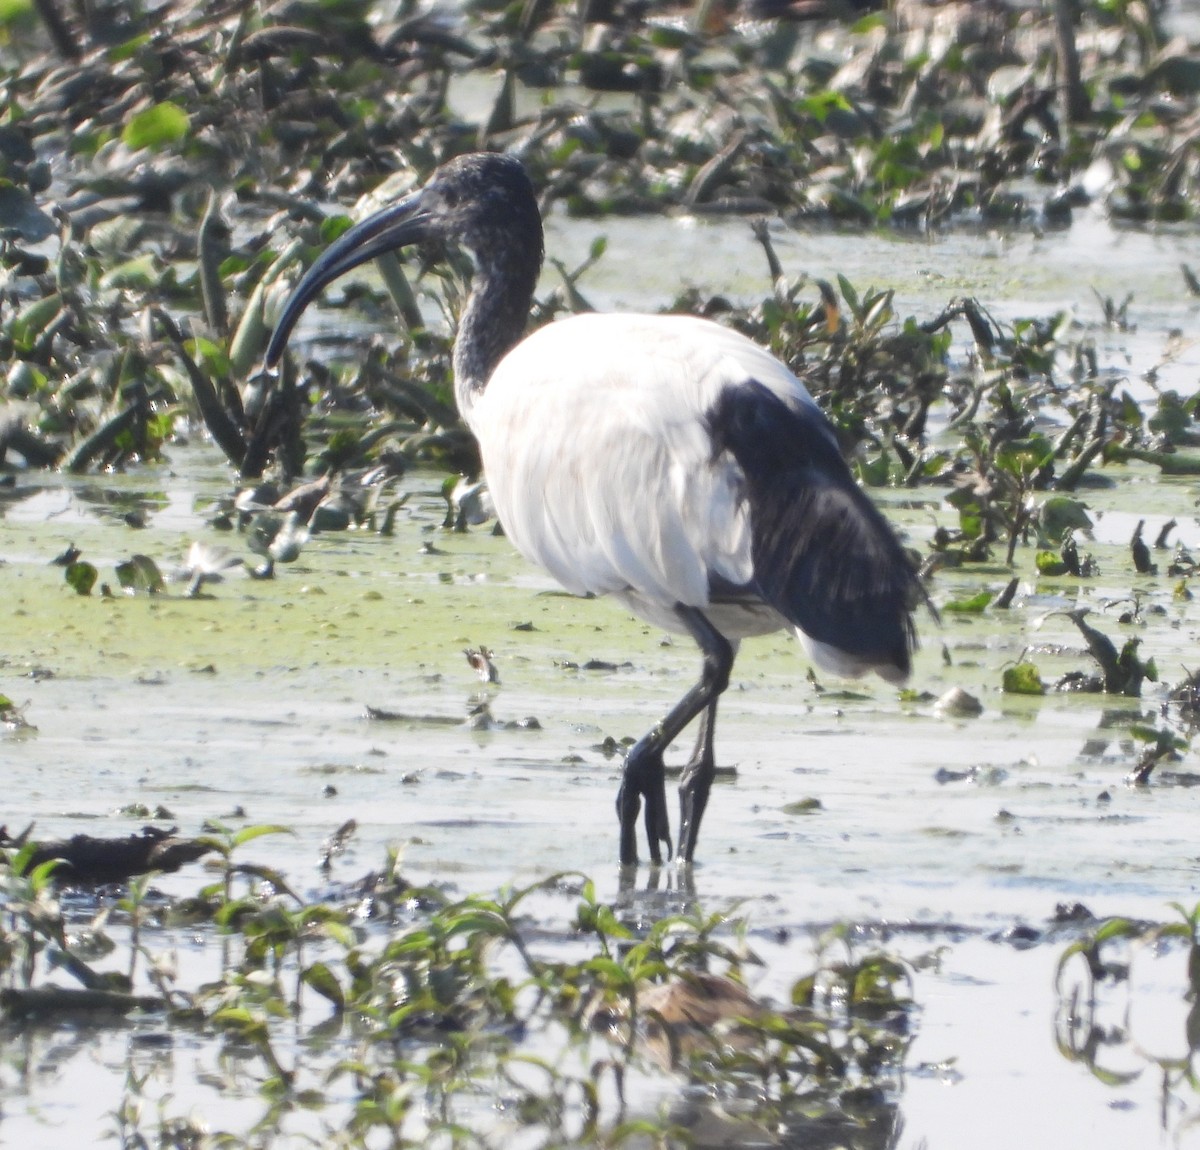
<box><xmin>266</xmin><ymin>154</ymin><xmax>919</xmax><ymax>864</ymax></box>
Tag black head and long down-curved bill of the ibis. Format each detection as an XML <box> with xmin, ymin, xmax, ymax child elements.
<box><xmin>266</xmin><ymin>152</ymin><xmax>542</xmax><ymax>367</ymax></box>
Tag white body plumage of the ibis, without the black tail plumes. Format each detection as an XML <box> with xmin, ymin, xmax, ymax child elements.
<box><xmin>466</xmin><ymin>315</ymin><xmax>777</xmax><ymax>607</ymax></box>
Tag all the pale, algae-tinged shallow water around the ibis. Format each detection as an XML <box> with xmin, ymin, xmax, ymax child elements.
<box><xmin>0</xmin><ymin>211</ymin><xmax>1200</xmax><ymax>1150</ymax></box>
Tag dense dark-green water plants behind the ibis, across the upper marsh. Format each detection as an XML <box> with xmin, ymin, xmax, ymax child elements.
<box><xmin>0</xmin><ymin>0</ymin><xmax>1200</xmax><ymax>492</ymax></box>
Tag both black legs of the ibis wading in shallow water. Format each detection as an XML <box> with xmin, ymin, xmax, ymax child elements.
<box><xmin>617</xmin><ymin>604</ymin><xmax>734</xmax><ymax>866</ymax></box>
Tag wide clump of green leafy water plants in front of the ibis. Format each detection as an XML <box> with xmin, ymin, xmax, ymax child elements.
<box><xmin>0</xmin><ymin>827</ymin><xmax>913</xmax><ymax>1146</ymax></box>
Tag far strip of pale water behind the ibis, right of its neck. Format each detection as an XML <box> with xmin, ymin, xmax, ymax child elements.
<box><xmin>546</xmin><ymin>205</ymin><xmax>1200</xmax><ymax>415</ymax></box>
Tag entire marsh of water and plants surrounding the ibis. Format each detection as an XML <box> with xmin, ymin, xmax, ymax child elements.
<box><xmin>0</xmin><ymin>0</ymin><xmax>1200</xmax><ymax>1148</ymax></box>
